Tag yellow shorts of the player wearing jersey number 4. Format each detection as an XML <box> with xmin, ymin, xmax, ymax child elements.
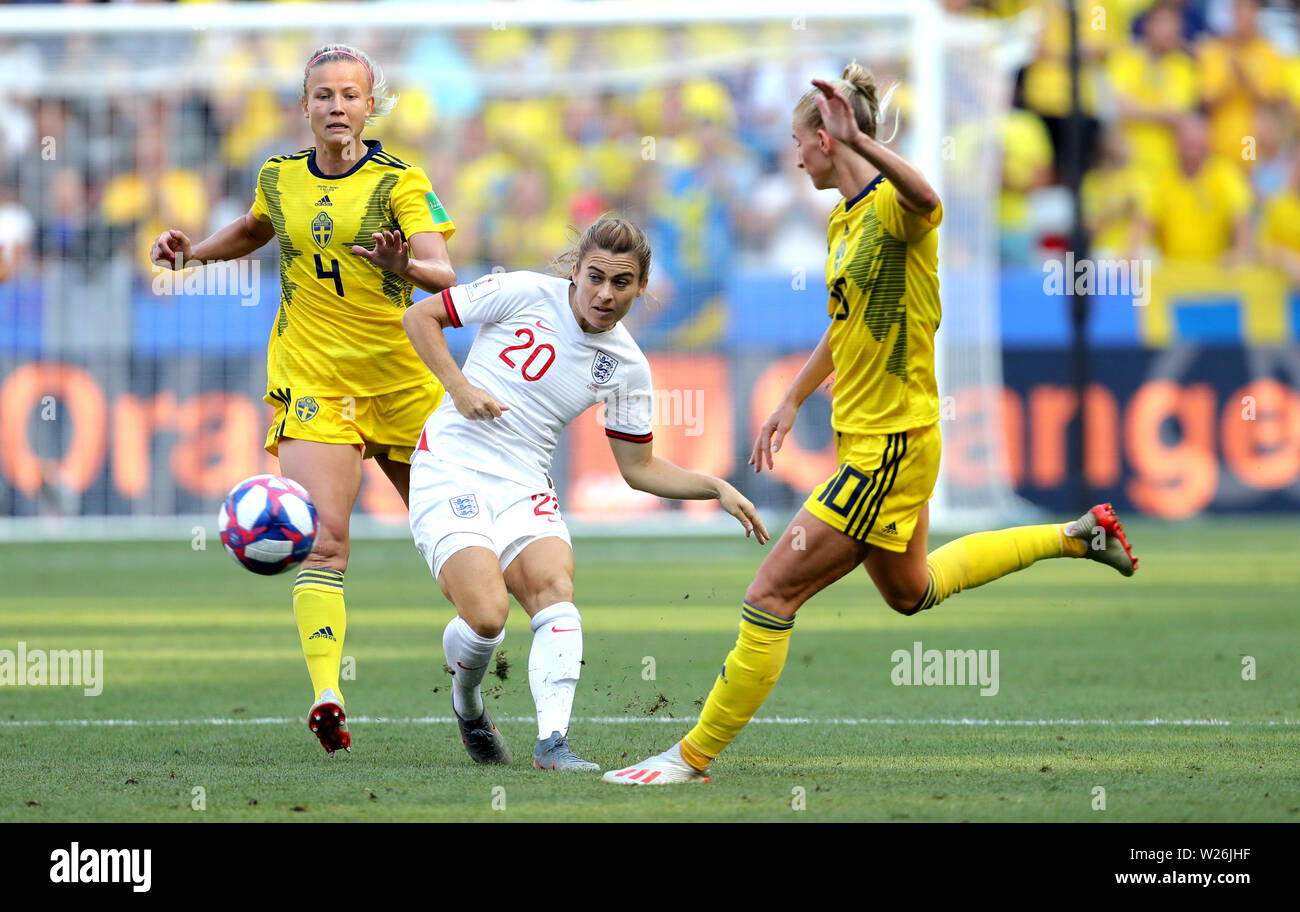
<box><xmin>265</xmin><ymin>378</ymin><xmax>443</xmax><ymax>462</ymax></box>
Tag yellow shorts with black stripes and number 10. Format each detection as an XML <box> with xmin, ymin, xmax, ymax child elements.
<box><xmin>803</xmin><ymin>424</ymin><xmax>941</xmax><ymax>551</ymax></box>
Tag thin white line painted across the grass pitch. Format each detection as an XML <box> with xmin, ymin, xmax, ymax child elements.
<box><xmin>0</xmin><ymin>716</ymin><xmax>1300</xmax><ymax>729</ymax></box>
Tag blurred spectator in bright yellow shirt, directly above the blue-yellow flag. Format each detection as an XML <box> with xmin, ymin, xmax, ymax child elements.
<box><xmin>1144</xmin><ymin>117</ymin><xmax>1252</xmax><ymax>266</ymax></box>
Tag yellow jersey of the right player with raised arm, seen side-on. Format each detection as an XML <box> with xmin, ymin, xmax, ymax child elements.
<box><xmin>826</xmin><ymin>175</ymin><xmax>944</xmax><ymax>434</ymax></box>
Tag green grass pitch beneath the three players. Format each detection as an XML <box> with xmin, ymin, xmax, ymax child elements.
<box><xmin>0</xmin><ymin>520</ymin><xmax>1300</xmax><ymax>822</ymax></box>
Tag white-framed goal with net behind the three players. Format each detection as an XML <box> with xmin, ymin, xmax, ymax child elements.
<box><xmin>0</xmin><ymin>0</ymin><xmax>1014</xmax><ymax>539</ymax></box>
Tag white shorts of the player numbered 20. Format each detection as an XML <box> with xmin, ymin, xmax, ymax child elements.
<box><xmin>410</xmin><ymin>452</ymin><xmax>573</xmax><ymax>579</ymax></box>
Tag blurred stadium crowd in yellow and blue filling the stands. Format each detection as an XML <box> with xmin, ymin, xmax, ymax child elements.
<box><xmin>0</xmin><ymin>0</ymin><xmax>1300</xmax><ymax>347</ymax></box>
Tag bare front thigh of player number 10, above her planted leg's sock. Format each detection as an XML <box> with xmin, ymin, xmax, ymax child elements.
<box><xmin>745</xmin><ymin>508</ymin><xmax>867</xmax><ymax>617</ymax></box>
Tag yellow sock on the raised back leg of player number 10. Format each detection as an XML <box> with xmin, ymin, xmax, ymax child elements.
<box><xmin>909</xmin><ymin>524</ymin><xmax>1088</xmax><ymax>613</ymax></box>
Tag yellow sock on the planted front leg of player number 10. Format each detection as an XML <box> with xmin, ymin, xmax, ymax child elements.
<box><xmin>681</xmin><ymin>602</ymin><xmax>794</xmax><ymax>769</ymax></box>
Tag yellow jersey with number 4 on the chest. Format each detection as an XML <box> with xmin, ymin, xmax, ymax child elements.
<box><xmin>252</xmin><ymin>139</ymin><xmax>456</xmax><ymax>396</ymax></box>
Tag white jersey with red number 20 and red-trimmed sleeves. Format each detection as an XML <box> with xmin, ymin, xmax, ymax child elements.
<box><xmin>416</xmin><ymin>272</ymin><xmax>653</xmax><ymax>488</ymax></box>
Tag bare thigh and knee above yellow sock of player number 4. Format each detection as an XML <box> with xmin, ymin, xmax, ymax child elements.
<box><xmin>280</xmin><ymin>438</ymin><xmax>361</xmax><ymax>569</ymax></box>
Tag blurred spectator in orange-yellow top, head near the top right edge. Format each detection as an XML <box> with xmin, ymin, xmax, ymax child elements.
<box><xmin>1199</xmin><ymin>0</ymin><xmax>1286</xmax><ymax>169</ymax></box>
